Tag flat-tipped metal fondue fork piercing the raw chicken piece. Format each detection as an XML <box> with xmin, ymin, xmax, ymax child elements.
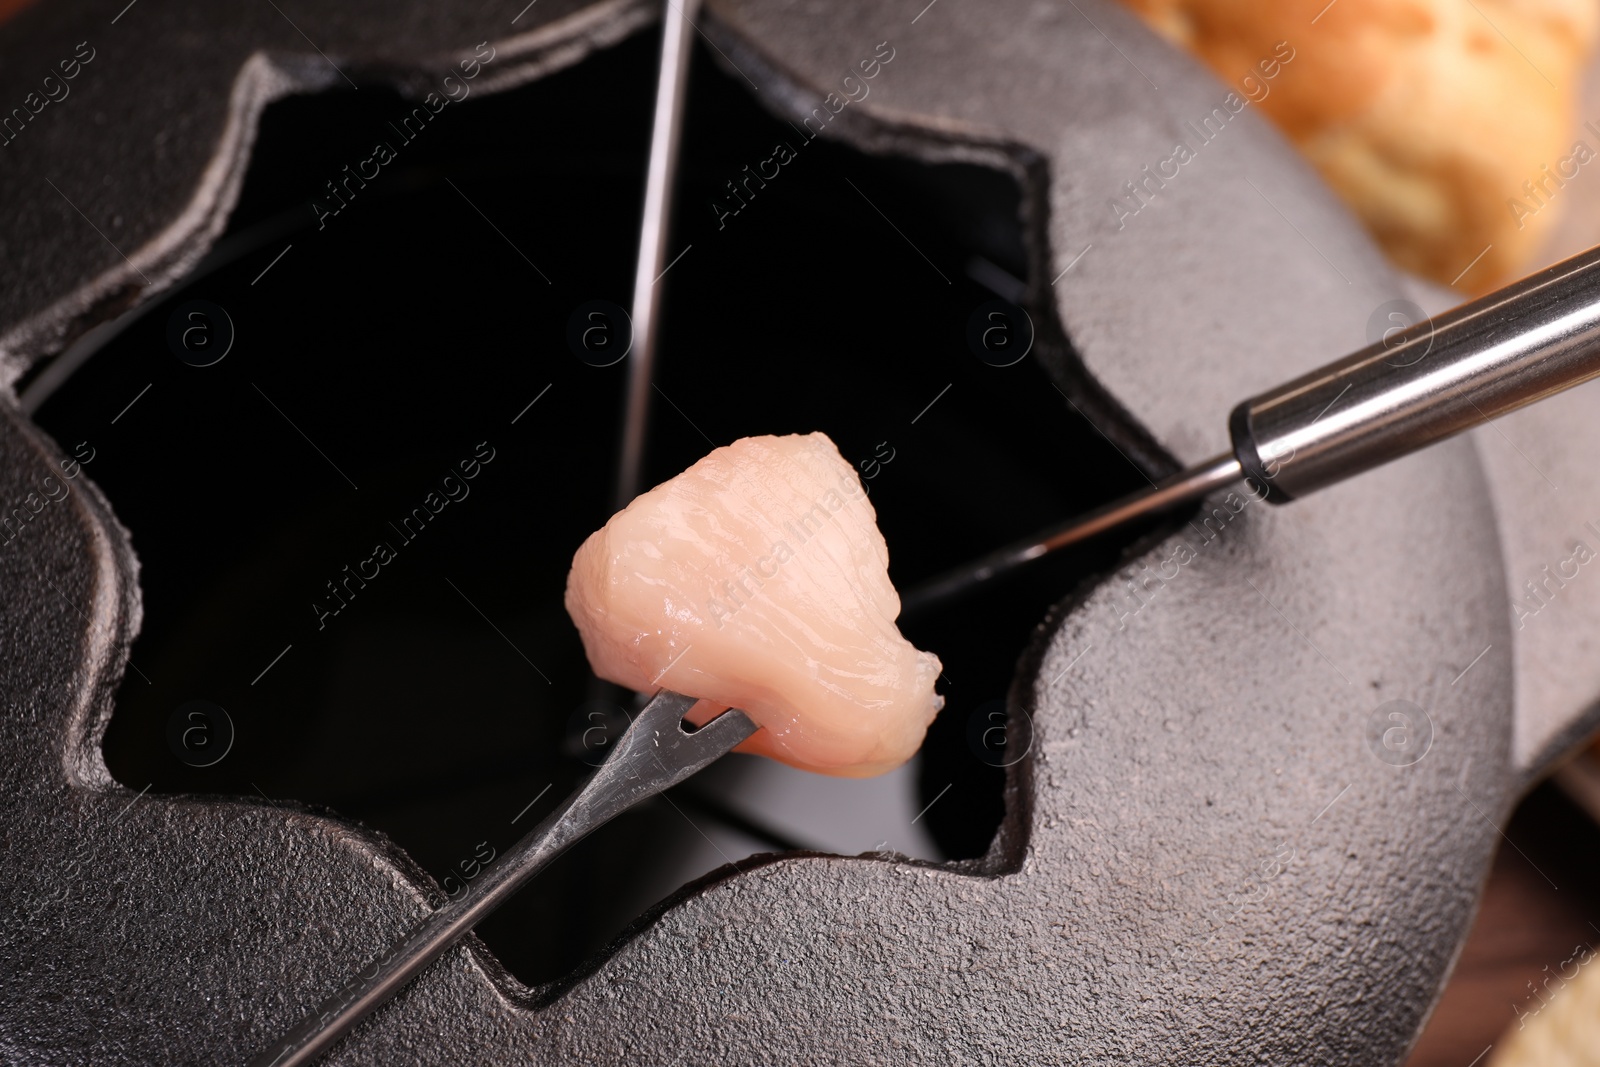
<box><xmin>251</xmin><ymin>689</ymin><xmax>758</xmax><ymax>1067</ymax></box>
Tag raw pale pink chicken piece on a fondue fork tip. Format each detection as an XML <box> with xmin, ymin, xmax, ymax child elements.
<box><xmin>566</xmin><ymin>434</ymin><xmax>944</xmax><ymax>777</ymax></box>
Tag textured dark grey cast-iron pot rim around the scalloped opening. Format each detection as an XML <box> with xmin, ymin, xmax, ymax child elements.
<box><xmin>0</xmin><ymin>0</ymin><xmax>1600</xmax><ymax>1065</ymax></box>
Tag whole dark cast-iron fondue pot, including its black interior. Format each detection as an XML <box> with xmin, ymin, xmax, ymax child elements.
<box><xmin>0</xmin><ymin>0</ymin><xmax>1600</xmax><ymax>1064</ymax></box>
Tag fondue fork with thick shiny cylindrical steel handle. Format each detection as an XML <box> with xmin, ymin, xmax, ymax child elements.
<box><xmin>902</xmin><ymin>241</ymin><xmax>1600</xmax><ymax>614</ymax></box>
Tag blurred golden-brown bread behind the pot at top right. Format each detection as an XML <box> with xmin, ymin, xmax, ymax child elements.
<box><xmin>1123</xmin><ymin>0</ymin><xmax>1600</xmax><ymax>293</ymax></box>
